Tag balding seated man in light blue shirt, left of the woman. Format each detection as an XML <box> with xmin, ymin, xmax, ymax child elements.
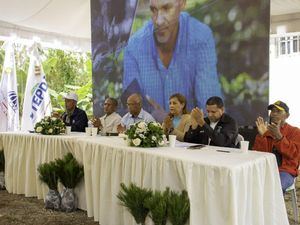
<box><xmin>118</xmin><ymin>93</ymin><xmax>155</xmax><ymax>133</ymax></box>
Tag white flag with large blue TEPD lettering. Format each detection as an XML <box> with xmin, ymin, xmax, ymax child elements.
<box><xmin>21</xmin><ymin>43</ymin><xmax>52</xmax><ymax>131</ymax></box>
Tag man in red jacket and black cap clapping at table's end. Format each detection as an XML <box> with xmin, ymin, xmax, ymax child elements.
<box><xmin>253</xmin><ymin>101</ymin><xmax>300</xmax><ymax>192</ymax></box>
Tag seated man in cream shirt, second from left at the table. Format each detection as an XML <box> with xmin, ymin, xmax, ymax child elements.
<box><xmin>92</xmin><ymin>98</ymin><xmax>121</xmax><ymax>133</ymax></box>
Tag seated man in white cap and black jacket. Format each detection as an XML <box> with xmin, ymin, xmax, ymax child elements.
<box><xmin>62</xmin><ymin>92</ymin><xmax>88</xmax><ymax>132</ymax></box>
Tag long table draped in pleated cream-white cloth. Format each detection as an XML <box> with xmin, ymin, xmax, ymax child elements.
<box><xmin>0</xmin><ymin>133</ymin><xmax>289</xmax><ymax>225</ymax></box>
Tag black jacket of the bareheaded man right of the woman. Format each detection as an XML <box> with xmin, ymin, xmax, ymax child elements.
<box><xmin>184</xmin><ymin>113</ymin><xmax>238</xmax><ymax>147</ymax></box>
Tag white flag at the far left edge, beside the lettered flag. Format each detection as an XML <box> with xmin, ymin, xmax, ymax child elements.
<box><xmin>0</xmin><ymin>41</ymin><xmax>19</xmax><ymax>131</ymax></box>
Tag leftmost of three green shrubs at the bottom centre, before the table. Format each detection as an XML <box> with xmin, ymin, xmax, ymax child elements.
<box><xmin>117</xmin><ymin>183</ymin><xmax>152</xmax><ymax>225</ymax></box>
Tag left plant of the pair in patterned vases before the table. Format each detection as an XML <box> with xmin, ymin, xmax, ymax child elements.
<box><xmin>37</xmin><ymin>162</ymin><xmax>61</xmax><ymax>210</ymax></box>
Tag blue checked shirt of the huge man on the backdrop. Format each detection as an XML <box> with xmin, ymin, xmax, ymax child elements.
<box><xmin>123</xmin><ymin>13</ymin><xmax>221</xmax><ymax>111</ymax></box>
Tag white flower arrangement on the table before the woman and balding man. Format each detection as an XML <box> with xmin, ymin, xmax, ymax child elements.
<box><xmin>125</xmin><ymin>121</ymin><xmax>164</xmax><ymax>148</ymax></box>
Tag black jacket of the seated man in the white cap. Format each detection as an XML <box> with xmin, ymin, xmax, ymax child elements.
<box><xmin>62</xmin><ymin>107</ymin><xmax>88</xmax><ymax>132</ymax></box>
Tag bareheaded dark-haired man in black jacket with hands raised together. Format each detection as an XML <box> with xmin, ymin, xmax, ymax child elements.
<box><xmin>184</xmin><ymin>96</ymin><xmax>238</xmax><ymax>147</ymax></box>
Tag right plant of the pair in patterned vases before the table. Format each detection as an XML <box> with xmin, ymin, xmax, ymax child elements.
<box><xmin>56</xmin><ymin>153</ymin><xmax>84</xmax><ymax>212</ymax></box>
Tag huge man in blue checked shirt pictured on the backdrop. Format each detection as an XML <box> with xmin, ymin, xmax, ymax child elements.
<box><xmin>123</xmin><ymin>0</ymin><xmax>221</xmax><ymax>116</ymax></box>
